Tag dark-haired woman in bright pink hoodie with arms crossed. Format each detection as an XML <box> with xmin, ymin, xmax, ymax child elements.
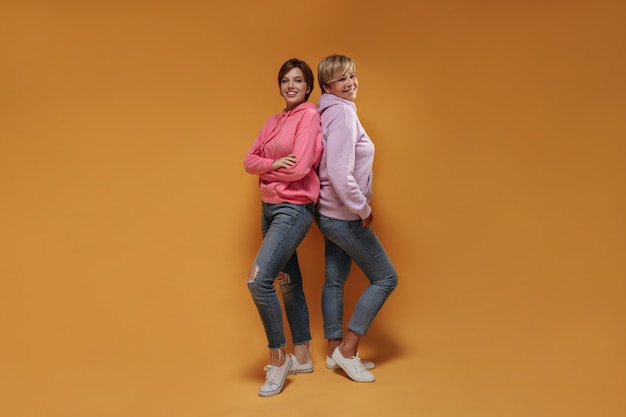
<box><xmin>244</xmin><ymin>59</ymin><xmax>322</xmax><ymax>397</ymax></box>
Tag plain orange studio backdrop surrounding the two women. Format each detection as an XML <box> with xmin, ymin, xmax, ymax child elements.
<box><xmin>0</xmin><ymin>0</ymin><xmax>626</xmax><ymax>417</ymax></box>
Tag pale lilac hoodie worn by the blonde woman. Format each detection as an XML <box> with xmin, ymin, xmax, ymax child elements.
<box><xmin>316</xmin><ymin>94</ymin><xmax>374</xmax><ymax>220</ymax></box>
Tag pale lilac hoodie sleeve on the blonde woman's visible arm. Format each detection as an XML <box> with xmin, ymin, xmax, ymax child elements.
<box><xmin>324</xmin><ymin>105</ymin><xmax>372</xmax><ymax>219</ymax></box>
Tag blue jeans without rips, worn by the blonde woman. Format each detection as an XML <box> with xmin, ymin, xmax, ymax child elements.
<box><xmin>315</xmin><ymin>213</ymin><xmax>398</xmax><ymax>339</ymax></box>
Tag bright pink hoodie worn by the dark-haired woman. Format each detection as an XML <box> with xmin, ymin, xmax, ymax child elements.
<box><xmin>243</xmin><ymin>103</ymin><xmax>323</xmax><ymax>204</ymax></box>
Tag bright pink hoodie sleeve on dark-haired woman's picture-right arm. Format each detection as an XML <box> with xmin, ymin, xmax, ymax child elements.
<box><xmin>261</xmin><ymin>108</ymin><xmax>322</xmax><ymax>181</ymax></box>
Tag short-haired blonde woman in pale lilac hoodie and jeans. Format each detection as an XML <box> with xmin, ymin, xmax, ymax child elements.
<box><xmin>315</xmin><ymin>55</ymin><xmax>398</xmax><ymax>382</ymax></box>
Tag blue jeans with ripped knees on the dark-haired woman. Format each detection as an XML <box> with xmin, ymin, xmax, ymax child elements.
<box><xmin>248</xmin><ymin>203</ymin><xmax>314</xmax><ymax>349</ymax></box>
